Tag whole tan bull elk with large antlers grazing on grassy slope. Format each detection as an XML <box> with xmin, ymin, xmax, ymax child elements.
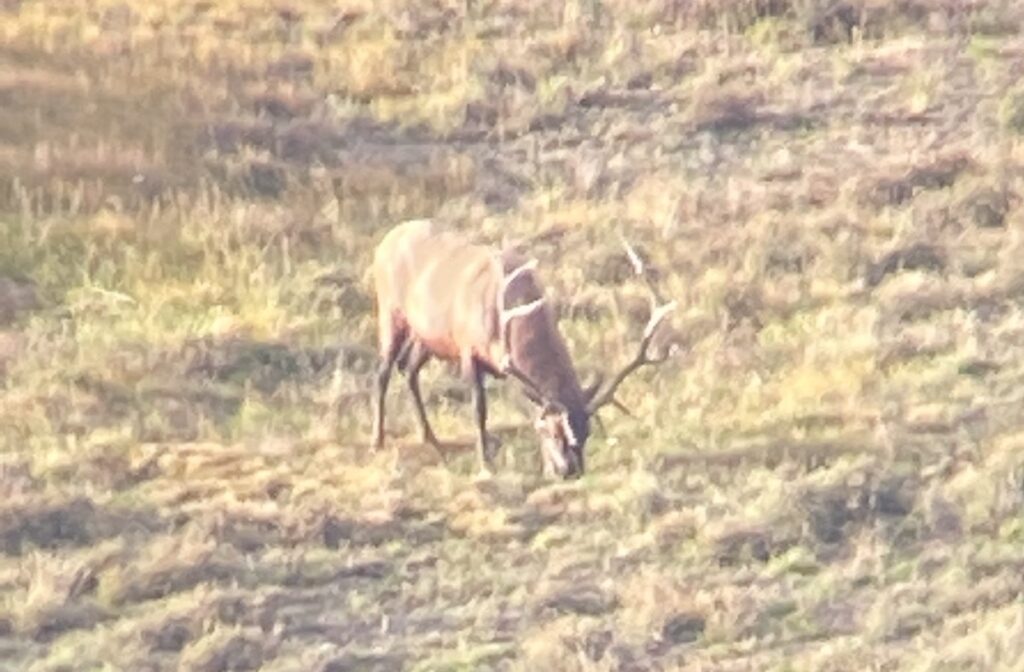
<box><xmin>372</xmin><ymin>219</ymin><xmax>676</xmax><ymax>479</ymax></box>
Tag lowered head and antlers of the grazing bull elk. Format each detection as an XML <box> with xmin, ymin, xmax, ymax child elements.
<box><xmin>498</xmin><ymin>237</ymin><xmax>676</xmax><ymax>478</ymax></box>
